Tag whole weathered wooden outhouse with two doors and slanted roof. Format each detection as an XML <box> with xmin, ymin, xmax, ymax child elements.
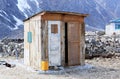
<box><xmin>24</xmin><ymin>11</ymin><xmax>87</xmax><ymax>69</ymax></box>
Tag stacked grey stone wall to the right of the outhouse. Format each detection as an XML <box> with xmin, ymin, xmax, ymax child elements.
<box><xmin>85</xmin><ymin>36</ymin><xmax>120</xmax><ymax>58</ymax></box>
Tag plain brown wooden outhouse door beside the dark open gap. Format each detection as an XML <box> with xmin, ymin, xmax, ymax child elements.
<box><xmin>68</xmin><ymin>22</ymin><xmax>80</xmax><ymax>66</ymax></box>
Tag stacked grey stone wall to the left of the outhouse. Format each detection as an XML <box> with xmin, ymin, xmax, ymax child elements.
<box><xmin>0</xmin><ymin>41</ymin><xmax>24</xmax><ymax>58</ymax></box>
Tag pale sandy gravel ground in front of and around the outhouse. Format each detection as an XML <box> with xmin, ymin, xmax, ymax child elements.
<box><xmin>0</xmin><ymin>58</ymin><xmax>120</xmax><ymax>79</ymax></box>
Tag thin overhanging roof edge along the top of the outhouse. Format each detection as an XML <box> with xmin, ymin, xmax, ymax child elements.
<box><xmin>23</xmin><ymin>11</ymin><xmax>89</xmax><ymax>22</ymax></box>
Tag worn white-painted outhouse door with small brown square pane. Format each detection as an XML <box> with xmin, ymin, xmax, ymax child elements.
<box><xmin>48</xmin><ymin>21</ymin><xmax>61</xmax><ymax>66</ymax></box>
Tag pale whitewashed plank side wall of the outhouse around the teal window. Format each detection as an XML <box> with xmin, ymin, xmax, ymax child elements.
<box><xmin>24</xmin><ymin>15</ymin><xmax>41</xmax><ymax>69</ymax></box>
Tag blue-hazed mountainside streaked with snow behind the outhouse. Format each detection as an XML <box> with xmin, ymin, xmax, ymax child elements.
<box><xmin>0</xmin><ymin>0</ymin><xmax>120</xmax><ymax>38</ymax></box>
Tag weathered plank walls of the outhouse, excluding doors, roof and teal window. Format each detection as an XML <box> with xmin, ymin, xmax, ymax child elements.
<box><xmin>24</xmin><ymin>14</ymin><xmax>85</xmax><ymax>69</ymax></box>
